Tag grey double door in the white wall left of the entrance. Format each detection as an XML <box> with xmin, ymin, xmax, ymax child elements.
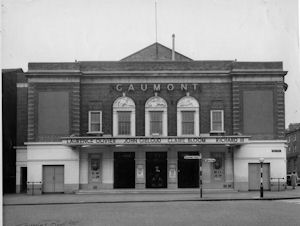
<box><xmin>43</xmin><ymin>166</ymin><xmax>64</xmax><ymax>193</ymax></box>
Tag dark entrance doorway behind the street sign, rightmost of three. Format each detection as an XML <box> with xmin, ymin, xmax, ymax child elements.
<box><xmin>178</xmin><ymin>152</ymin><xmax>199</xmax><ymax>188</ymax></box>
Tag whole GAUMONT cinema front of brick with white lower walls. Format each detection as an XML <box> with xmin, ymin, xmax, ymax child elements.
<box><xmin>16</xmin><ymin>43</ymin><xmax>287</xmax><ymax>193</ymax></box>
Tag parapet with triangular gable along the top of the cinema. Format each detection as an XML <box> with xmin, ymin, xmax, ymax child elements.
<box><xmin>27</xmin><ymin>42</ymin><xmax>287</xmax><ymax>75</ymax></box>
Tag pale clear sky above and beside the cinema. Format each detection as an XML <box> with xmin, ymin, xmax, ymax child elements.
<box><xmin>1</xmin><ymin>0</ymin><xmax>300</xmax><ymax>127</ymax></box>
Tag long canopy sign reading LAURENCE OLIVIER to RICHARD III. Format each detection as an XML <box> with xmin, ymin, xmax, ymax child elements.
<box><xmin>62</xmin><ymin>136</ymin><xmax>249</xmax><ymax>145</ymax></box>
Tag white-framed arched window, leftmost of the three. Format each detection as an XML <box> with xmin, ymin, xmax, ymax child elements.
<box><xmin>113</xmin><ymin>94</ymin><xmax>135</xmax><ymax>136</ymax></box>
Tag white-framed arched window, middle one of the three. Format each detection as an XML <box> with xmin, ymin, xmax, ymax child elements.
<box><xmin>145</xmin><ymin>93</ymin><xmax>168</xmax><ymax>136</ymax></box>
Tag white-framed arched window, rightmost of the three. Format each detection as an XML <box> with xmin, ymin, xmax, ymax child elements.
<box><xmin>177</xmin><ymin>93</ymin><xmax>199</xmax><ymax>136</ymax></box>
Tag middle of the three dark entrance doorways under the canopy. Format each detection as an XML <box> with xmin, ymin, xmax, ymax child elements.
<box><xmin>146</xmin><ymin>152</ymin><xmax>167</xmax><ymax>188</ymax></box>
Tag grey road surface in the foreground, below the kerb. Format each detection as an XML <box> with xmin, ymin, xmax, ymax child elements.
<box><xmin>3</xmin><ymin>199</ymin><xmax>300</xmax><ymax>226</ymax></box>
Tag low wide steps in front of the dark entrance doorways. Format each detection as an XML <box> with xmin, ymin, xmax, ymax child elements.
<box><xmin>76</xmin><ymin>188</ymin><xmax>237</xmax><ymax>195</ymax></box>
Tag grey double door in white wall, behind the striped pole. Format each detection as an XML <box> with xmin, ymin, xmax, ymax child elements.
<box><xmin>249</xmin><ymin>163</ymin><xmax>270</xmax><ymax>190</ymax></box>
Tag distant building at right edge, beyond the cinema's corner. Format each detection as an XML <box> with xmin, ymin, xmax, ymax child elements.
<box><xmin>286</xmin><ymin>123</ymin><xmax>300</xmax><ymax>176</ymax></box>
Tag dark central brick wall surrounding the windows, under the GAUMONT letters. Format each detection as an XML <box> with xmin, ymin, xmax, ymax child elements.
<box><xmin>80</xmin><ymin>83</ymin><xmax>232</xmax><ymax>136</ymax></box>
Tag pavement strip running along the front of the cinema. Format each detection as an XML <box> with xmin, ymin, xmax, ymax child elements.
<box><xmin>3</xmin><ymin>186</ymin><xmax>300</xmax><ymax>206</ymax></box>
